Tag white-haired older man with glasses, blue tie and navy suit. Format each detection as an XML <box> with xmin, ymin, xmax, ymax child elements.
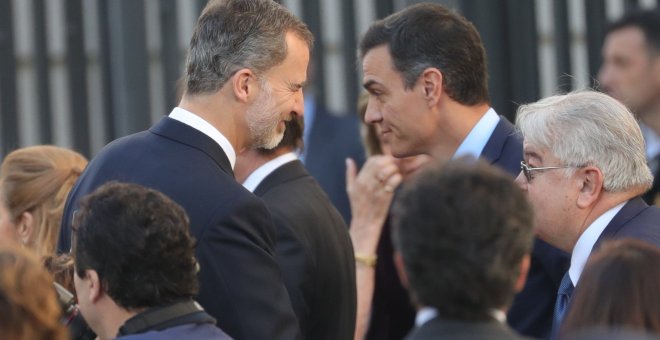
<box><xmin>516</xmin><ymin>91</ymin><xmax>660</xmax><ymax>337</ymax></box>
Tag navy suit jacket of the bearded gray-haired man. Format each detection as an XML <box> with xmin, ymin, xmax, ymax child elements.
<box><xmin>59</xmin><ymin>117</ymin><xmax>300</xmax><ymax>339</ymax></box>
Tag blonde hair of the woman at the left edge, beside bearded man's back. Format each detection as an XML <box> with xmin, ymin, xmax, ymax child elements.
<box><xmin>0</xmin><ymin>145</ymin><xmax>87</xmax><ymax>257</ymax></box>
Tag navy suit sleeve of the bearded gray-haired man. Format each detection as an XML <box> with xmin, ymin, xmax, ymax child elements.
<box><xmin>197</xmin><ymin>197</ymin><xmax>300</xmax><ymax>339</ymax></box>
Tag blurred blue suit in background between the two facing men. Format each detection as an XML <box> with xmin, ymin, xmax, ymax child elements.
<box><xmin>305</xmin><ymin>108</ymin><xmax>365</xmax><ymax>223</ymax></box>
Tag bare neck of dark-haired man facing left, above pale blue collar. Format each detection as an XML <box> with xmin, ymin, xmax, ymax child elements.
<box><xmin>430</xmin><ymin>97</ymin><xmax>490</xmax><ymax>159</ymax></box>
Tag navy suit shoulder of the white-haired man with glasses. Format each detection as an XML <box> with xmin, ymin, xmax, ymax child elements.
<box><xmin>593</xmin><ymin>197</ymin><xmax>660</xmax><ymax>249</ymax></box>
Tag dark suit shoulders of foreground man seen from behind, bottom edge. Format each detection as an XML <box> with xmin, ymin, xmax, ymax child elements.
<box><xmin>406</xmin><ymin>317</ymin><xmax>526</xmax><ymax>340</ymax></box>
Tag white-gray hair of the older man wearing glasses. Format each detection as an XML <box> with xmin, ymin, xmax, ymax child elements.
<box><xmin>516</xmin><ymin>91</ymin><xmax>653</xmax><ymax>192</ymax></box>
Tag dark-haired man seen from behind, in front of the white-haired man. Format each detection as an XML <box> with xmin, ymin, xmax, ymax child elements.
<box><xmin>393</xmin><ymin>158</ymin><xmax>533</xmax><ymax>339</ymax></box>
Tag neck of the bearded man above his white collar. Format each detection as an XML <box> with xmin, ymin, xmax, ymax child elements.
<box><xmin>179</xmin><ymin>88</ymin><xmax>248</xmax><ymax>152</ymax></box>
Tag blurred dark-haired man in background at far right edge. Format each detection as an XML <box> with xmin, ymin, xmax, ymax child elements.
<box><xmin>598</xmin><ymin>9</ymin><xmax>660</xmax><ymax>205</ymax></box>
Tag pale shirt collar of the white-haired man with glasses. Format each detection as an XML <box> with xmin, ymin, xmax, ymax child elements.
<box><xmin>568</xmin><ymin>201</ymin><xmax>627</xmax><ymax>287</ymax></box>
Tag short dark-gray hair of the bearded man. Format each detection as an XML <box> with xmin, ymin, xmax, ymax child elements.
<box><xmin>186</xmin><ymin>0</ymin><xmax>314</xmax><ymax>95</ymax></box>
